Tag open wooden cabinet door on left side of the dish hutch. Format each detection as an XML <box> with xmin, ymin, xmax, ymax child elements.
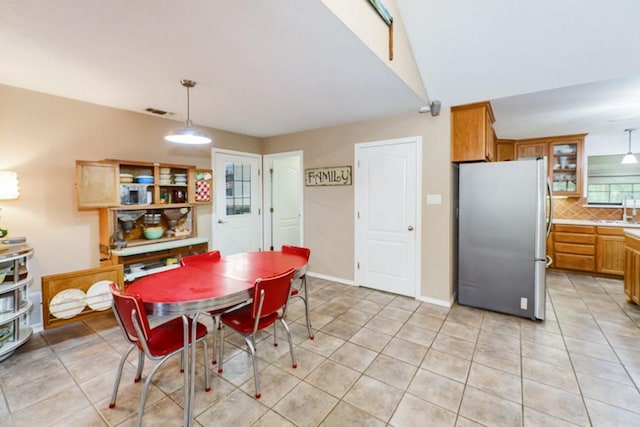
<box><xmin>75</xmin><ymin>160</ymin><xmax>120</xmax><ymax>209</ymax></box>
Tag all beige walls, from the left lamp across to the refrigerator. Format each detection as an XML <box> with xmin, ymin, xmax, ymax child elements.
<box><xmin>0</xmin><ymin>85</ymin><xmax>452</xmax><ymax>316</ymax></box>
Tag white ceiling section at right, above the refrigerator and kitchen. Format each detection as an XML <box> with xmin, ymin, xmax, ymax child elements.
<box><xmin>398</xmin><ymin>0</ymin><xmax>640</xmax><ymax>139</ymax></box>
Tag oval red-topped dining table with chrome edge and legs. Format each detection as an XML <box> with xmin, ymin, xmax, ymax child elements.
<box><xmin>125</xmin><ymin>251</ymin><xmax>307</xmax><ymax>426</ymax></box>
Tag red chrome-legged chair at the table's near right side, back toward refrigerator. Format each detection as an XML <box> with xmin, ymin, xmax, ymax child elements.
<box><xmin>218</xmin><ymin>268</ymin><xmax>298</xmax><ymax>399</ymax></box>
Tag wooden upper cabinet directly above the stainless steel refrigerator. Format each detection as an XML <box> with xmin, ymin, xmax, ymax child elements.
<box><xmin>451</xmin><ymin>102</ymin><xmax>496</xmax><ymax>163</ymax></box>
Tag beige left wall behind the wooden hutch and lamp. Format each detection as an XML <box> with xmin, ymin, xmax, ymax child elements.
<box><xmin>0</xmin><ymin>85</ymin><xmax>260</xmax><ymax>289</ymax></box>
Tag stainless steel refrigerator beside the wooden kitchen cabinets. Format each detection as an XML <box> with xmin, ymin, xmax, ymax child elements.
<box><xmin>457</xmin><ymin>158</ymin><xmax>553</xmax><ymax>319</ymax></box>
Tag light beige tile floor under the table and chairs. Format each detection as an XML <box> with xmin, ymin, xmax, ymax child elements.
<box><xmin>0</xmin><ymin>272</ymin><xmax>640</xmax><ymax>427</ymax></box>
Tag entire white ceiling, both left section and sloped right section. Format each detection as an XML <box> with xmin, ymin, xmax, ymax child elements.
<box><xmin>0</xmin><ymin>0</ymin><xmax>640</xmax><ymax>143</ymax></box>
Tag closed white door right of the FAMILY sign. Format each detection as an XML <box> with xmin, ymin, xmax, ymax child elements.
<box><xmin>355</xmin><ymin>137</ymin><xmax>421</xmax><ymax>297</ymax></box>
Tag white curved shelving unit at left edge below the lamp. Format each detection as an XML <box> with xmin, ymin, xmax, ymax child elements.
<box><xmin>0</xmin><ymin>244</ymin><xmax>33</xmax><ymax>361</ymax></box>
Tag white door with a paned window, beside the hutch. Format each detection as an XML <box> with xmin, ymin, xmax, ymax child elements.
<box><xmin>211</xmin><ymin>149</ymin><xmax>262</xmax><ymax>255</ymax></box>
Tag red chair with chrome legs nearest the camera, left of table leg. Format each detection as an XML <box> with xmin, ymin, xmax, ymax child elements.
<box><xmin>109</xmin><ymin>283</ymin><xmax>211</xmax><ymax>426</ymax></box>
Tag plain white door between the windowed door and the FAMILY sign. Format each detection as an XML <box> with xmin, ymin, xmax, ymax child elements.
<box><xmin>263</xmin><ymin>152</ymin><xmax>302</xmax><ymax>250</ymax></box>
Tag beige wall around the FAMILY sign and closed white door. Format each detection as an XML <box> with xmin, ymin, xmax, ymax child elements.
<box><xmin>263</xmin><ymin>108</ymin><xmax>453</xmax><ymax>302</ymax></box>
